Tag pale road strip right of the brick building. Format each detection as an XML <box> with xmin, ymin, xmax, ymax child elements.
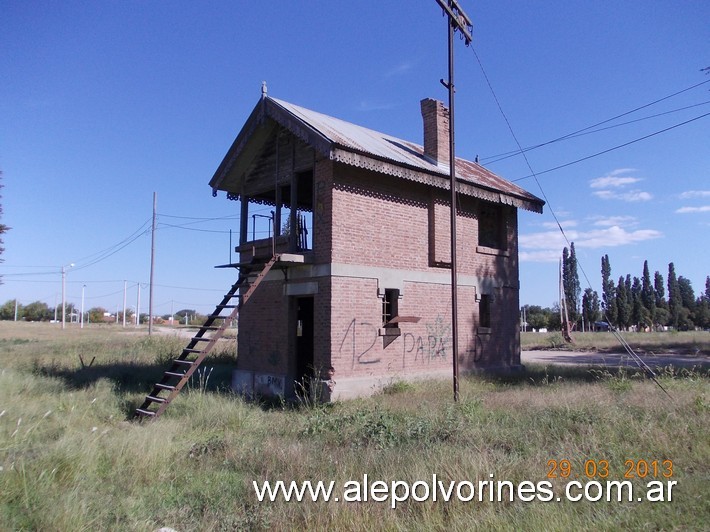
<box><xmin>521</xmin><ymin>351</ymin><xmax>710</xmax><ymax>368</ymax></box>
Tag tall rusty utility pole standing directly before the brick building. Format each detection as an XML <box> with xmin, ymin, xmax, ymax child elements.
<box><xmin>436</xmin><ymin>0</ymin><xmax>473</xmax><ymax>402</ymax></box>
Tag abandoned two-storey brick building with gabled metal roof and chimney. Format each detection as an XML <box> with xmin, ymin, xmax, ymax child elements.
<box><xmin>210</xmin><ymin>90</ymin><xmax>544</xmax><ymax>398</ymax></box>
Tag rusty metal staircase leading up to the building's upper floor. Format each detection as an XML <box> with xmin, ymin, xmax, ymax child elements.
<box><xmin>135</xmin><ymin>255</ymin><xmax>280</xmax><ymax>419</ymax></box>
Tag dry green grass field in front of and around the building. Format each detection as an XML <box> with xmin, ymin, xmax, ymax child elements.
<box><xmin>0</xmin><ymin>322</ymin><xmax>710</xmax><ymax>531</ymax></box>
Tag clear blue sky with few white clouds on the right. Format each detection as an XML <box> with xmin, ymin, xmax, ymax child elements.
<box><xmin>0</xmin><ymin>0</ymin><xmax>710</xmax><ymax>314</ymax></box>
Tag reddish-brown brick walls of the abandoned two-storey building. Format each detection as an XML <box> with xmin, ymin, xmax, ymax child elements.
<box><xmin>237</xmin><ymin>156</ymin><xmax>520</xmax><ymax>392</ymax></box>
